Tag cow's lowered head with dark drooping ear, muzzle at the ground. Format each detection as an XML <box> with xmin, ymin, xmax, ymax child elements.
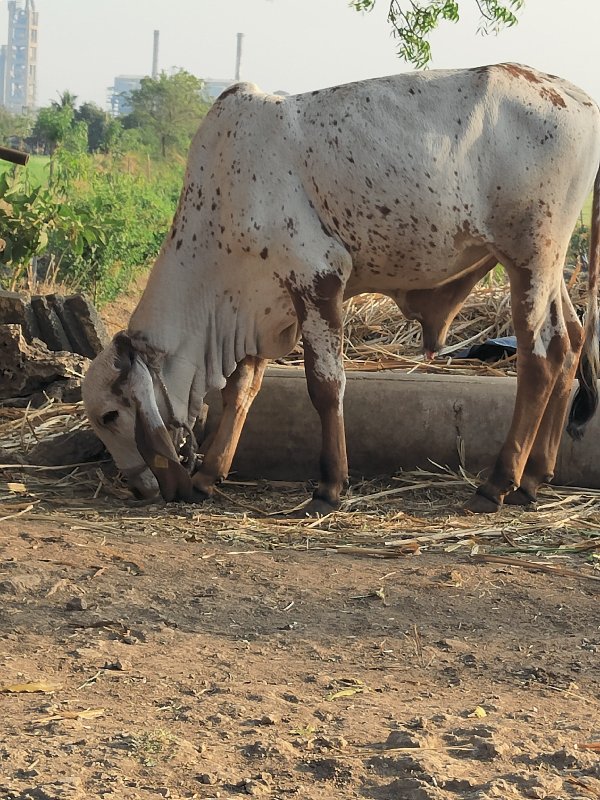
<box><xmin>82</xmin><ymin>332</ymin><xmax>192</xmax><ymax>501</ymax></box>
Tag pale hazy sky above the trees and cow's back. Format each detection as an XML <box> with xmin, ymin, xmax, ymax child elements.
<box><xmin>0</xmin><ymin>0</ymin><xmax>600</xmax><ymax>107</ymax></box>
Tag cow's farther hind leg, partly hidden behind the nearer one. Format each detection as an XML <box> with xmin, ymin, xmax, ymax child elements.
<box><xmin>504</xmin><ymin>284</ymin><xmax>583</xmax><ymax>505</ymax></box>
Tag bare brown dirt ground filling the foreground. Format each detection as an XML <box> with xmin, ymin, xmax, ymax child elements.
<box><xmin>0</xmin><ymin>474</ymin><xmax>600</xmax><ymax>800</ymax></box>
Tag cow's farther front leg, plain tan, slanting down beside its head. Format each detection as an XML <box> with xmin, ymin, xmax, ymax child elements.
<box><xmin>192</xmin><ymin>356</ymin><xmax>268</xmax><ymax>497</ymax></box>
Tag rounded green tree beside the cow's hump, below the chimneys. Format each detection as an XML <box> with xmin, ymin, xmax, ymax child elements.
<box><xmin>123</xmin><ymin>70</ymin><xmax>209</xmax><ymax>158</ymax></box>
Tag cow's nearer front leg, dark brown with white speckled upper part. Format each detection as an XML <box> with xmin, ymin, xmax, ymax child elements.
<box><xmin>294</xmin><ymin>279</ymin><xmax>348</xmax><ymax>516</ymax></box>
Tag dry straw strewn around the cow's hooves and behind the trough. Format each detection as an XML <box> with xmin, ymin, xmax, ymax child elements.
<box><xmin>0</xmin><ymin>286</ymin><xmax>600</xmax><ymax>580</ymax></box>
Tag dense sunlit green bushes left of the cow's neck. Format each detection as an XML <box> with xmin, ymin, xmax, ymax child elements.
<box><xmin>0</xmin><ymin>146</ymin><xmax>183</xmax><ymax>304</ymax></box>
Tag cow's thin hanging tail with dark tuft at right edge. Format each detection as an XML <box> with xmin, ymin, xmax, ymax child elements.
<box><xmin>567</xmin><ymin>169</ymin><xmax>600</xmax><ymax>439</ymax></box>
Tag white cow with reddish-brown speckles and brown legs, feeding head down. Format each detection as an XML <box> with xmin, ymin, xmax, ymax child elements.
<box><xmin>83</xmin><ymin>63</ymin><xmax>600</xmax><ymax>515</ymax></box>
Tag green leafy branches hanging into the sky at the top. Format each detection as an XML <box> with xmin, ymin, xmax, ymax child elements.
<box><xmin>350</xmin><ymin>0</ymin><xmax>525</xmax><ymax>68</ymax></box>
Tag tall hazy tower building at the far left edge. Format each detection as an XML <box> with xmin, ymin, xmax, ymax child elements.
<box><xmin>0</xmin><ymin>0</ymin><xmax>38</xmax><ymax>114</ymax></box>
